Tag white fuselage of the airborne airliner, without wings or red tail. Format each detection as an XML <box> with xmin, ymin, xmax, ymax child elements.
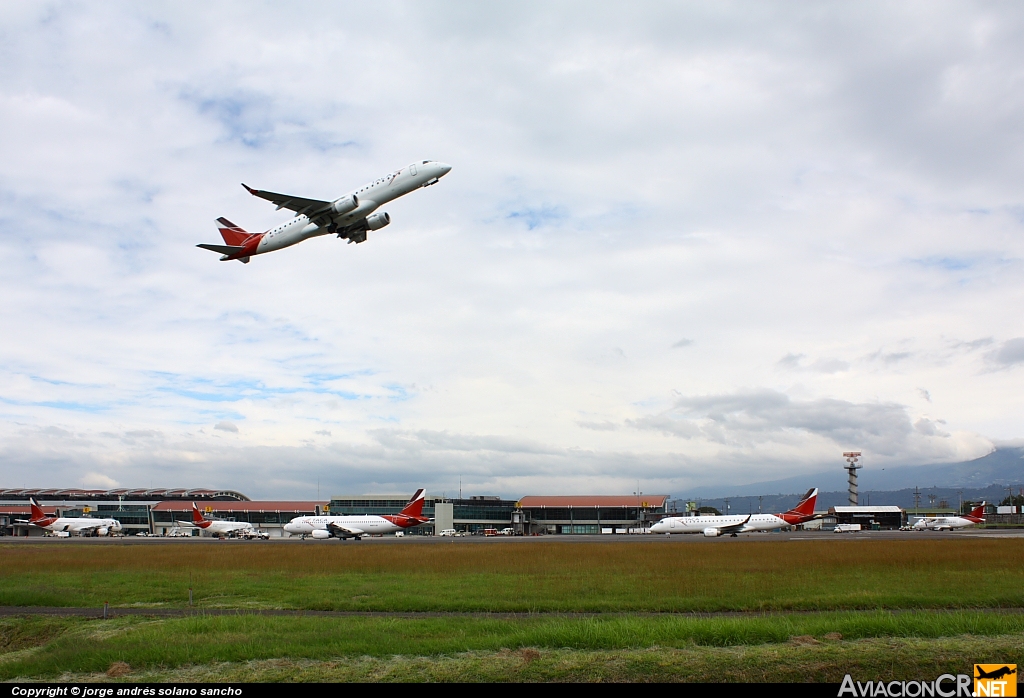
<box><xmin>257</xmin><ymin>161</ymin><xmax>452</xmax><ymax>254</ymax></box>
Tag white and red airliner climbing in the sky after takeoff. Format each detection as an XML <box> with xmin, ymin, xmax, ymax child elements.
<box><xmin>196</xmin><ymin>160</ymin><xmax>452</xmax><ymax>264</ymax></box>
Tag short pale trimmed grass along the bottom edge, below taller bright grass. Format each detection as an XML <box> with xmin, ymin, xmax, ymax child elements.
<box><xmin>29</xmin><ymin>637</ymin><xmax>1022</xmax><ymax>684</ymax></box>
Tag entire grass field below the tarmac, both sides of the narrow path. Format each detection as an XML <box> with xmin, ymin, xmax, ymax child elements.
<box><xmin>0</xmin><ymin>538</ymin><xmax>1024</xmax><ymax>681</ymax></box>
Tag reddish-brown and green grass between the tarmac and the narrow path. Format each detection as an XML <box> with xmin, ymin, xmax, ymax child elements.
<box><xmin>0</xmin><ymin>538</ymin><xmax>1024</xmax><ymax>612</ymax></box>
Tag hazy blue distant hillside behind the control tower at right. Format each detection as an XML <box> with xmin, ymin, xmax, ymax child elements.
<box><xmin>677</xmin><ymin>448</ymin><xmax>1024</xmax><ymax>513</ymax></box>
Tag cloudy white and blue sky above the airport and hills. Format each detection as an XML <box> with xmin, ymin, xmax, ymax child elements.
<box><xmin>0</xmin><ymin>2</ymin><xmax>1024</xmax><ymax>497</ymax></box>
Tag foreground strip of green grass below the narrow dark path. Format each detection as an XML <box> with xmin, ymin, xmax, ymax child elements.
<box><xmin>0</xmin><ymin>612</ymin><xmax>1024</xmax><ymax>681</ymax></box>
